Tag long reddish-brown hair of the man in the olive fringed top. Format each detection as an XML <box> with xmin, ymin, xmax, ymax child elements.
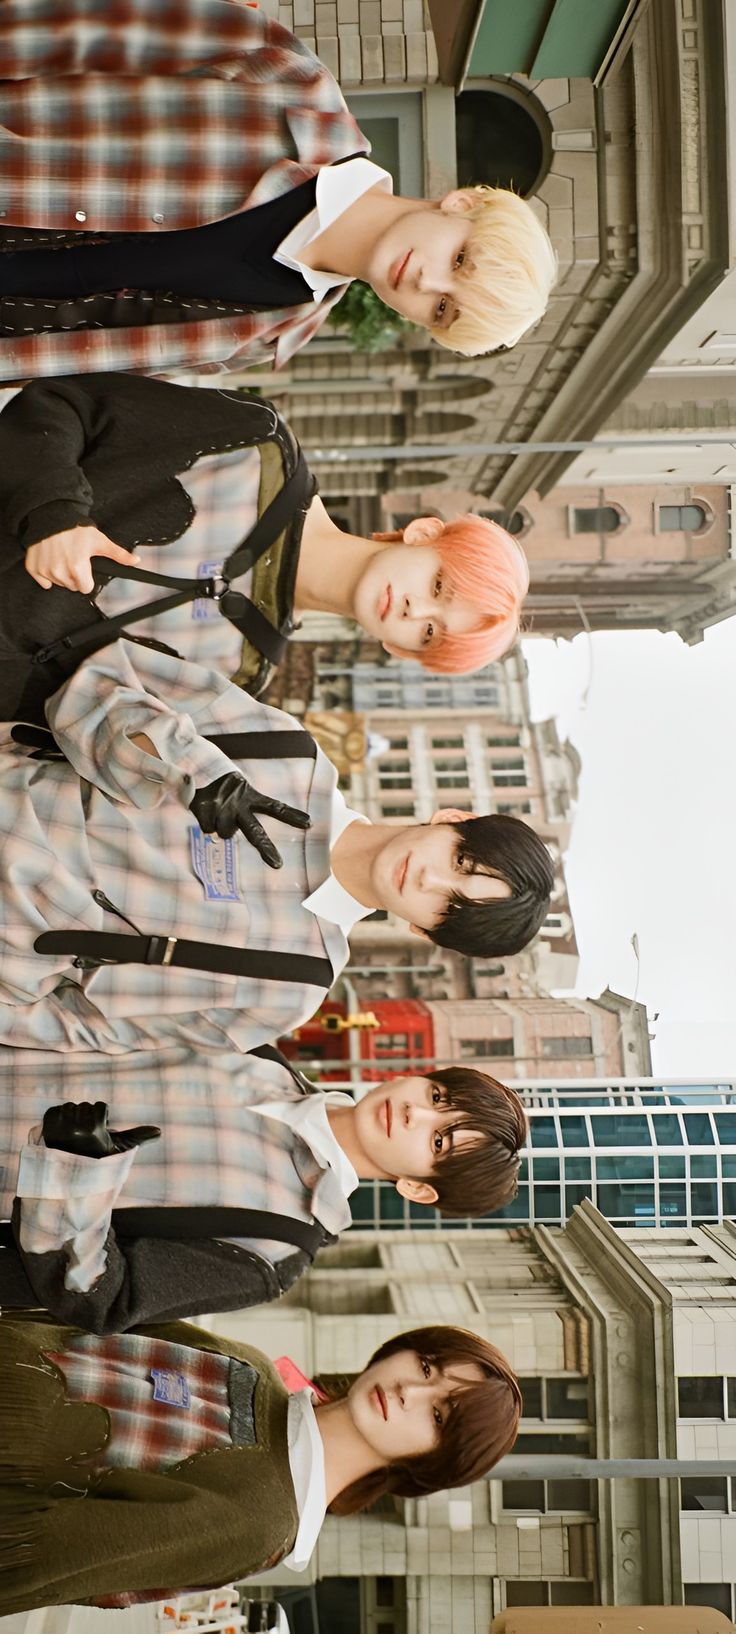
<box><xmin>330</xmin><ymin>1327</ymin><xmax>522</xmax><ymax>1515</ymax></box>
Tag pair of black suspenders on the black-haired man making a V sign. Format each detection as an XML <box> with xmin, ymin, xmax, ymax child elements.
<box><xmin>33</xmin><ymin>730</ymin><xmax>334</xmax><ymax>989</ymax></box>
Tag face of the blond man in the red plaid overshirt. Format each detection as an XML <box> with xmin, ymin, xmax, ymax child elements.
<box><xmin>363</xmin><ymin>193</ymin><xmax>468</xmax><ymax>330</ymax></box>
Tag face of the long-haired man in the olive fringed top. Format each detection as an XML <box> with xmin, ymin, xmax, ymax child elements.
<box><xmin>347</xmin><ymin>1350</ymin><xmax>484</xmax><ymax>1464</ymax></box>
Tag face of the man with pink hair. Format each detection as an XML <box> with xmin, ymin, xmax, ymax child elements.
<box><xmin>353</xmin><ymin>539</ymin><xmax>481</xmax><ymax>657</ymax></box>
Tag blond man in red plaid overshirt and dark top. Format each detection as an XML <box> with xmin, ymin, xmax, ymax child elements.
<box><xmin>0</xmin><ymin>0</ymin><xmax>556</xmax><ymax>381</ymax></box>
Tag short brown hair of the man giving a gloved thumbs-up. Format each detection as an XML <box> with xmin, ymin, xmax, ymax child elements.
<box><xmin>425</xmin><ymin>1067</ymin><xmax>528</xmax><ymax>1216</ymax></box>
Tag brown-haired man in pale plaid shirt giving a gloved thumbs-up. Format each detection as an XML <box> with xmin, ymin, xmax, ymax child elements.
<box><xmin>0</xmin><ymin>1046</ymin><xmax>527</xmax><ymax>1333</ymax></box>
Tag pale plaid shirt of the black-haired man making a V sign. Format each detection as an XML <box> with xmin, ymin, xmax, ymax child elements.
<box><xmin>0</xmin><ymin>641</ymin><xmax>361</xmax><ymax>1054</ymax></box>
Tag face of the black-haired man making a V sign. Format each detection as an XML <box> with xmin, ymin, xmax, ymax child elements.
<box><xmin>371</xmin><ymin>810</ymin><xmax>510</xmax><ymax>931</ymax></box>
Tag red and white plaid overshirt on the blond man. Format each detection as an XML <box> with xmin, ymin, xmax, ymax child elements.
<box><xmin>0</xmin><ymin>0</ymin><xmax>370</xmax><ymax>381</ymax></box>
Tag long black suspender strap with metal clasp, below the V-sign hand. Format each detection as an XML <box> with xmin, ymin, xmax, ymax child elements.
<box><xmin>33</xmin><ymin>928</ymin><xmax>335</xmax><ymax>989</ymax></box>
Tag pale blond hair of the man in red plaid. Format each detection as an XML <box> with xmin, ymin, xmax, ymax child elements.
<box><xmin>430</xmin><ymin>186</ymin><xmax>558</xmax><ymax>358</ymax></box>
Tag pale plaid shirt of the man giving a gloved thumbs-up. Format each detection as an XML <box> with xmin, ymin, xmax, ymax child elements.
<box><xmin>7</xmin><ymin>1046</ymin><xmax>358</xmax><ymax>1291</ymax></box>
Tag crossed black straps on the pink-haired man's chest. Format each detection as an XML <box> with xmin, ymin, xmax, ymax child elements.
<box><xmin>31</xmin><ymin>449</ymin><xmax>316</xmax><ymax>663</ymax></box>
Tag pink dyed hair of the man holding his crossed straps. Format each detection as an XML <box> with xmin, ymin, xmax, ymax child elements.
<box><xmin>417</xmin><ymin>515</ymin><xmax>528</xmax><ymax>675</ymax></box>
